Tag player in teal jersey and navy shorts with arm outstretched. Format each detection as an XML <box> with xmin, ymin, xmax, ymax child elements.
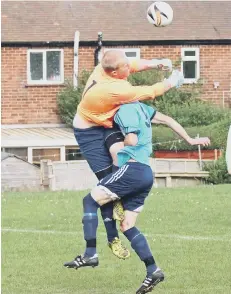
<box><xmin>64</xmin><ymin>102</ymin><xmax>210</xmax><ymax>294</ymax></box>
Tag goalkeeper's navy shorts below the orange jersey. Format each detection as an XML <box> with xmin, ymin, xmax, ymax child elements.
<box><xmin>74</xmin><ymin>126</ymin><xmax>123</xmax><ymax>179</ymax></box>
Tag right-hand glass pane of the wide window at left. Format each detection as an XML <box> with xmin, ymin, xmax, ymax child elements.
<box><xmin>47</xmin><ymin>51</ymin><xmax>61</xmax><ymax>81</ymax></box>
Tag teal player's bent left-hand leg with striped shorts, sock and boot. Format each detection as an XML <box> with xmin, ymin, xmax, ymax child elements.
<box><xmin>64</xmin><ymin>162</ymin><xmax>149</xmax><ymax>268</ymax></box>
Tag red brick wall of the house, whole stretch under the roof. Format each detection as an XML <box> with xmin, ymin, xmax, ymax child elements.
<box><xmin>2</xmin><ymin>45</ymin><xmax>231</xmax><ymax>124</ymax></box>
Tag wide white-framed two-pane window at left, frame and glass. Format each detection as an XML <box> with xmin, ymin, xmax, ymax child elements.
<box><xmin>27</xmin><ymin>49</ymin><xmax>64</xmax><ymax>85</ymax></box>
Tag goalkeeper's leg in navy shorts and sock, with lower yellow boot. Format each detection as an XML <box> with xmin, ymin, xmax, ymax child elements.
<box><xmin>74</xmin><ymin>127</ymin><xmax>130</xmax><ymax>259</ymax></box>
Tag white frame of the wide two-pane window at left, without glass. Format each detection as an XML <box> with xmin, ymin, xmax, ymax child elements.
<box><xmin>27</xmin><ymin>49</ymin><xmax>64</xmax><ymax>85</ymax></box>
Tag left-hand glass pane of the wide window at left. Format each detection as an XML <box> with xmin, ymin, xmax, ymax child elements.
<box><xmin>30</xmin><ymin>53</ymin><xmax>43</xmax><ymax>81</ymax></box>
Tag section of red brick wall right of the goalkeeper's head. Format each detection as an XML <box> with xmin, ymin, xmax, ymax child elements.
<box><xmin>141</xmin><ymin>45</ymin><xmax>231</xmax><ymax>107</ymax></box>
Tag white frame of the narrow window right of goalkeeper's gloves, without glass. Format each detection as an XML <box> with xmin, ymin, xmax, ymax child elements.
<box><xmin>181</xmin><ymin>48</ymin><xmax>200</xmax><ymax>84</ymax></box>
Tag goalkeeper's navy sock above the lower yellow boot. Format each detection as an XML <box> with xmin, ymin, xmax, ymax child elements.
<box><xmin>100</xmin><ymin>202</ymin><xmax>119</xmax><ymax>242</ymax></box>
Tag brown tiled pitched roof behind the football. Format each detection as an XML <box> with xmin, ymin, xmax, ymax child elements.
<box><xmin>2</xmin><ymin>1</ymin><xmax>231</xmax><ymax>42</ymax></box>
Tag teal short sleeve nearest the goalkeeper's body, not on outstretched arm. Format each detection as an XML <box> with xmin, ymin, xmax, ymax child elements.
<box><xmin>114</xmin><ymin>103</ymin><xmax>140</xmax><ymax>135</ymax></box>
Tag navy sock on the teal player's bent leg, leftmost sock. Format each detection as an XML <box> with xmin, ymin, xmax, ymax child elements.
<box><xmin>82</xmin><ymin>194</ymin><xmax>100</xmax><ymax>256</ymax></box>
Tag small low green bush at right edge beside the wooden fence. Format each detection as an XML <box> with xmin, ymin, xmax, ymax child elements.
<box><xmin>203</xmin><ymin>152</ymin><xmax>231</xmax><ymax>185</ymax></box>
